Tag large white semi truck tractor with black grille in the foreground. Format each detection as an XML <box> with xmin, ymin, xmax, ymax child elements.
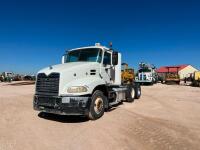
<box><xmin>33</xmin><ymin>43</ymin><xmax>141</xmax><ymax>120</ymax></box>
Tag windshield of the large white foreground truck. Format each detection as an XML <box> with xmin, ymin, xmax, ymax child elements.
<box><xmin>65</xmin><ymin>48</ymin><xmax>102</xmax><ymax>63</ymax></box>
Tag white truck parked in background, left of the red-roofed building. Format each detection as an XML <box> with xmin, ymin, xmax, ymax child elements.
<box><xmin>135</xmin><ymin>62</ymin><xmax>158</xmax><ymax>85</ymax></box>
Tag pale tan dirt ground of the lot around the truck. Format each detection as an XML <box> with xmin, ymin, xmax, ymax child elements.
<box><xmin>0</xmin><ymin>83</ymin><xmax>200</xmax><ymax>150</ymax></box>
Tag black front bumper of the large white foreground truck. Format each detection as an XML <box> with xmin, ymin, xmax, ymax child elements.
<box><xmin>33</xmin><ymin>95</ymin><xmax>90</xmax><ymax>115</ymax></box>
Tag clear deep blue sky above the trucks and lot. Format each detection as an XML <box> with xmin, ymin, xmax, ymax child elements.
<box><xmin>0</xmin><ymin>0</ymin><xmax>200</xmax><ymax>74</ymax></box>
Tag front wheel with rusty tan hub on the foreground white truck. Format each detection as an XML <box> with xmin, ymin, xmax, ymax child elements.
<box><xmin>88</xmin><ymin>90</ymin><xmax>106</xmax><ymax>120</ymax></box>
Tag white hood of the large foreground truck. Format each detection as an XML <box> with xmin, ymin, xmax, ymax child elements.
<box><xmin>38</xmin><ymin>62</ymin><xmax>101</xmax><ymax>95</ymax></box>
